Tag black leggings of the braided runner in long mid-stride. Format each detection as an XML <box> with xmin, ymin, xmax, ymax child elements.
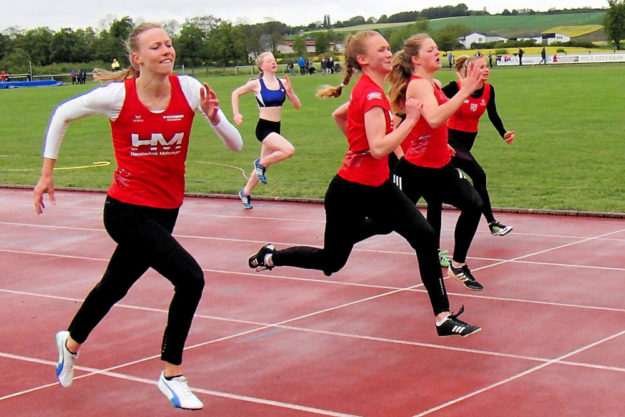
<box><xmin>273</xmin><ymin>175</ymin><xmax>449</xmax><ymax>315</ymax></box>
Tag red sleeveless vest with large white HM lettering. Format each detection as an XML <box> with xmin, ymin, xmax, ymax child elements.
<box><xmin>108</xmin><ymin>75</ymin><xmax>195</xmax><ymax>208</ymax></box>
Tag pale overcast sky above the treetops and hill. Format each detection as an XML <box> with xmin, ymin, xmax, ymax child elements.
<box><xmin>0</xmin><ymin>0</ymin><xmax>608</xmax><ymax>31</ymax></box>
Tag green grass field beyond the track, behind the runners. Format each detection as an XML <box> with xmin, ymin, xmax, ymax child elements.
<box><xmin>0</xmin><ymin>64</ymin><xmax>625</xmax><ymax>213</ymax></box>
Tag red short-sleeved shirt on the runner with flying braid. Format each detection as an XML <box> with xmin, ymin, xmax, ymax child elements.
<box><xmin>338</xmin><ymin>74</ymin><xmax>393</xmax><ymax>187</ymax></box>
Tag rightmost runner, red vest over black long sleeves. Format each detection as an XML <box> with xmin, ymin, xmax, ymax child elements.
<box><xmin>443</xmin><ymin>55</ymin><xmax>514</xmax><ymax>236</ymax></box>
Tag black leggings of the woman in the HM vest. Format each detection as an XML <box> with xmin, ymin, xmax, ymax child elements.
<box><xmin>69</xmin><ymin>197</ymin><xmax>204</xmax><ymax>365</ymax></box>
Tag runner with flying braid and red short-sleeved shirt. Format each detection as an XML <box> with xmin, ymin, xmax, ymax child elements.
<box><xmin>249</xmin><ymin>31</ymin><xmax>481</xmax><ymax>336</ymax></box>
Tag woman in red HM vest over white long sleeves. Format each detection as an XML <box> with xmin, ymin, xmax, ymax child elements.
<box><xmin>34</xmin><ymin>23</ymin><xmax>242</xmax><ymax>409</ymax></box>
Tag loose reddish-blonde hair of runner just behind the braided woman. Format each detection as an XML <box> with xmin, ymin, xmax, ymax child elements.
<box><xmin>386</xmin><ymin>33</ymin><xmax>431</xmax><ymax>113</ymax></box>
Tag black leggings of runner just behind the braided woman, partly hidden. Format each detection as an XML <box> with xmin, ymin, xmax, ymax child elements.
<box><xmin>394</xmin><ymin>158</ymin><xmax>482</xmax><ymax>263</ymax></box>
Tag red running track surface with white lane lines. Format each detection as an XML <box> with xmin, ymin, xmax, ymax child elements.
<box><xmin>0</xmin><ymin>189</ymin><xmax>625</xmax><ymax>417</ymax></box>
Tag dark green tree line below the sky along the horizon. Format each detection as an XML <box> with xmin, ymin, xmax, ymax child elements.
<box><xmin>0</xmin><ymin>0</ymin><xmax>625</xmax><ymax>73</ymax></box>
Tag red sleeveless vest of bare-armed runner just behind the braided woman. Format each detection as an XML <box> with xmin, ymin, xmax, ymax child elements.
<box><xmin>402</xmin><ymin>75</ymin><xmax>451</xmax><ymax>168</ymax></box>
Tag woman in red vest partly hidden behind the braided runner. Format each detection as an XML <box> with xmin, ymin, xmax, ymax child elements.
<box><xmin>389</xmin><ymin>34</ymin><xmax>483</xmax><ymax>291</ymax></box>
